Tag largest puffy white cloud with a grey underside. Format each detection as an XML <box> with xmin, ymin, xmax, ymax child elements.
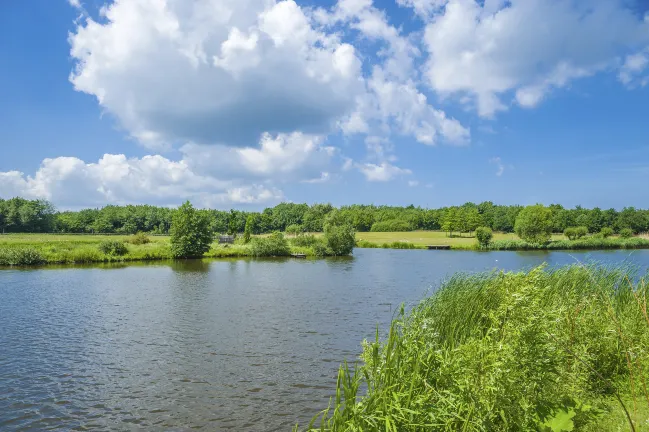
<box><xmin>70</xmin><ymin>0</ymin><xmax>363</xmax><ymax>146</ymax></box>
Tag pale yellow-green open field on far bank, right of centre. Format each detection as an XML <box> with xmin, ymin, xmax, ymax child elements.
<box><xmin>356</xmin><ymin>231</ymin><xmax>565</xmax><ymax>247</ymax></box>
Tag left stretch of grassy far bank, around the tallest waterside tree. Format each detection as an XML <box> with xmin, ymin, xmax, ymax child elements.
<box><xmin>0</xmin><ymin>234</ymin><xmax>316</xmax><ymax>266</ymax></box>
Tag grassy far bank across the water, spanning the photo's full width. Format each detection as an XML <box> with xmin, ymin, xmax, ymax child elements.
<box><xmin>0</xmin><ymin>231</ymin><xmax>649</xmax><ymax>266</ymax></box>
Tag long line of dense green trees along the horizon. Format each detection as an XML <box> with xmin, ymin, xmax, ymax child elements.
<box><xmin>0</xmin><ymin>198</ymin><xmax>649</xmax><ymax>235</ymax></box>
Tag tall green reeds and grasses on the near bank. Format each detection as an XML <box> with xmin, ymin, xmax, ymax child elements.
<box><xmin>302</xmin><ymin>266</ymin><xmax>649</xmax><ymax>432</ymax></box>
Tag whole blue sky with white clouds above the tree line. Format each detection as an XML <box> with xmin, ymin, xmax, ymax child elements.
<box><xmin>0</xmin><ymin>0</ymin><xmax>649</xmax><ymax>209</ymax></box>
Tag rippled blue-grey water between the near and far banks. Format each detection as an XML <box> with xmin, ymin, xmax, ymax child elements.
<box><xmin>0</xmin><ymin>249</ymin><xmax>649</xmax><ymax>431</ymax></box>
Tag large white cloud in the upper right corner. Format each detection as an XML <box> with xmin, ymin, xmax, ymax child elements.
<box><xmin>420</xmin><ymin>0</ymin><xmax>649</xmax><ymax>117</ymax></box>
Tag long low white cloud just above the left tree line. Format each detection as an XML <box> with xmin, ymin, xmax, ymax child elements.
<box><xmin>0</xmin><ymin>154</ymin><xmax>283</xmax><ymax>208</ymax></box>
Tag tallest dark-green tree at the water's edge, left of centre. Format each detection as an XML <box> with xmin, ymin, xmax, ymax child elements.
<box><xmin>171</xmin><ymin>201</ymin><xmax>213</xmax><ymax>258</ymax></box>
